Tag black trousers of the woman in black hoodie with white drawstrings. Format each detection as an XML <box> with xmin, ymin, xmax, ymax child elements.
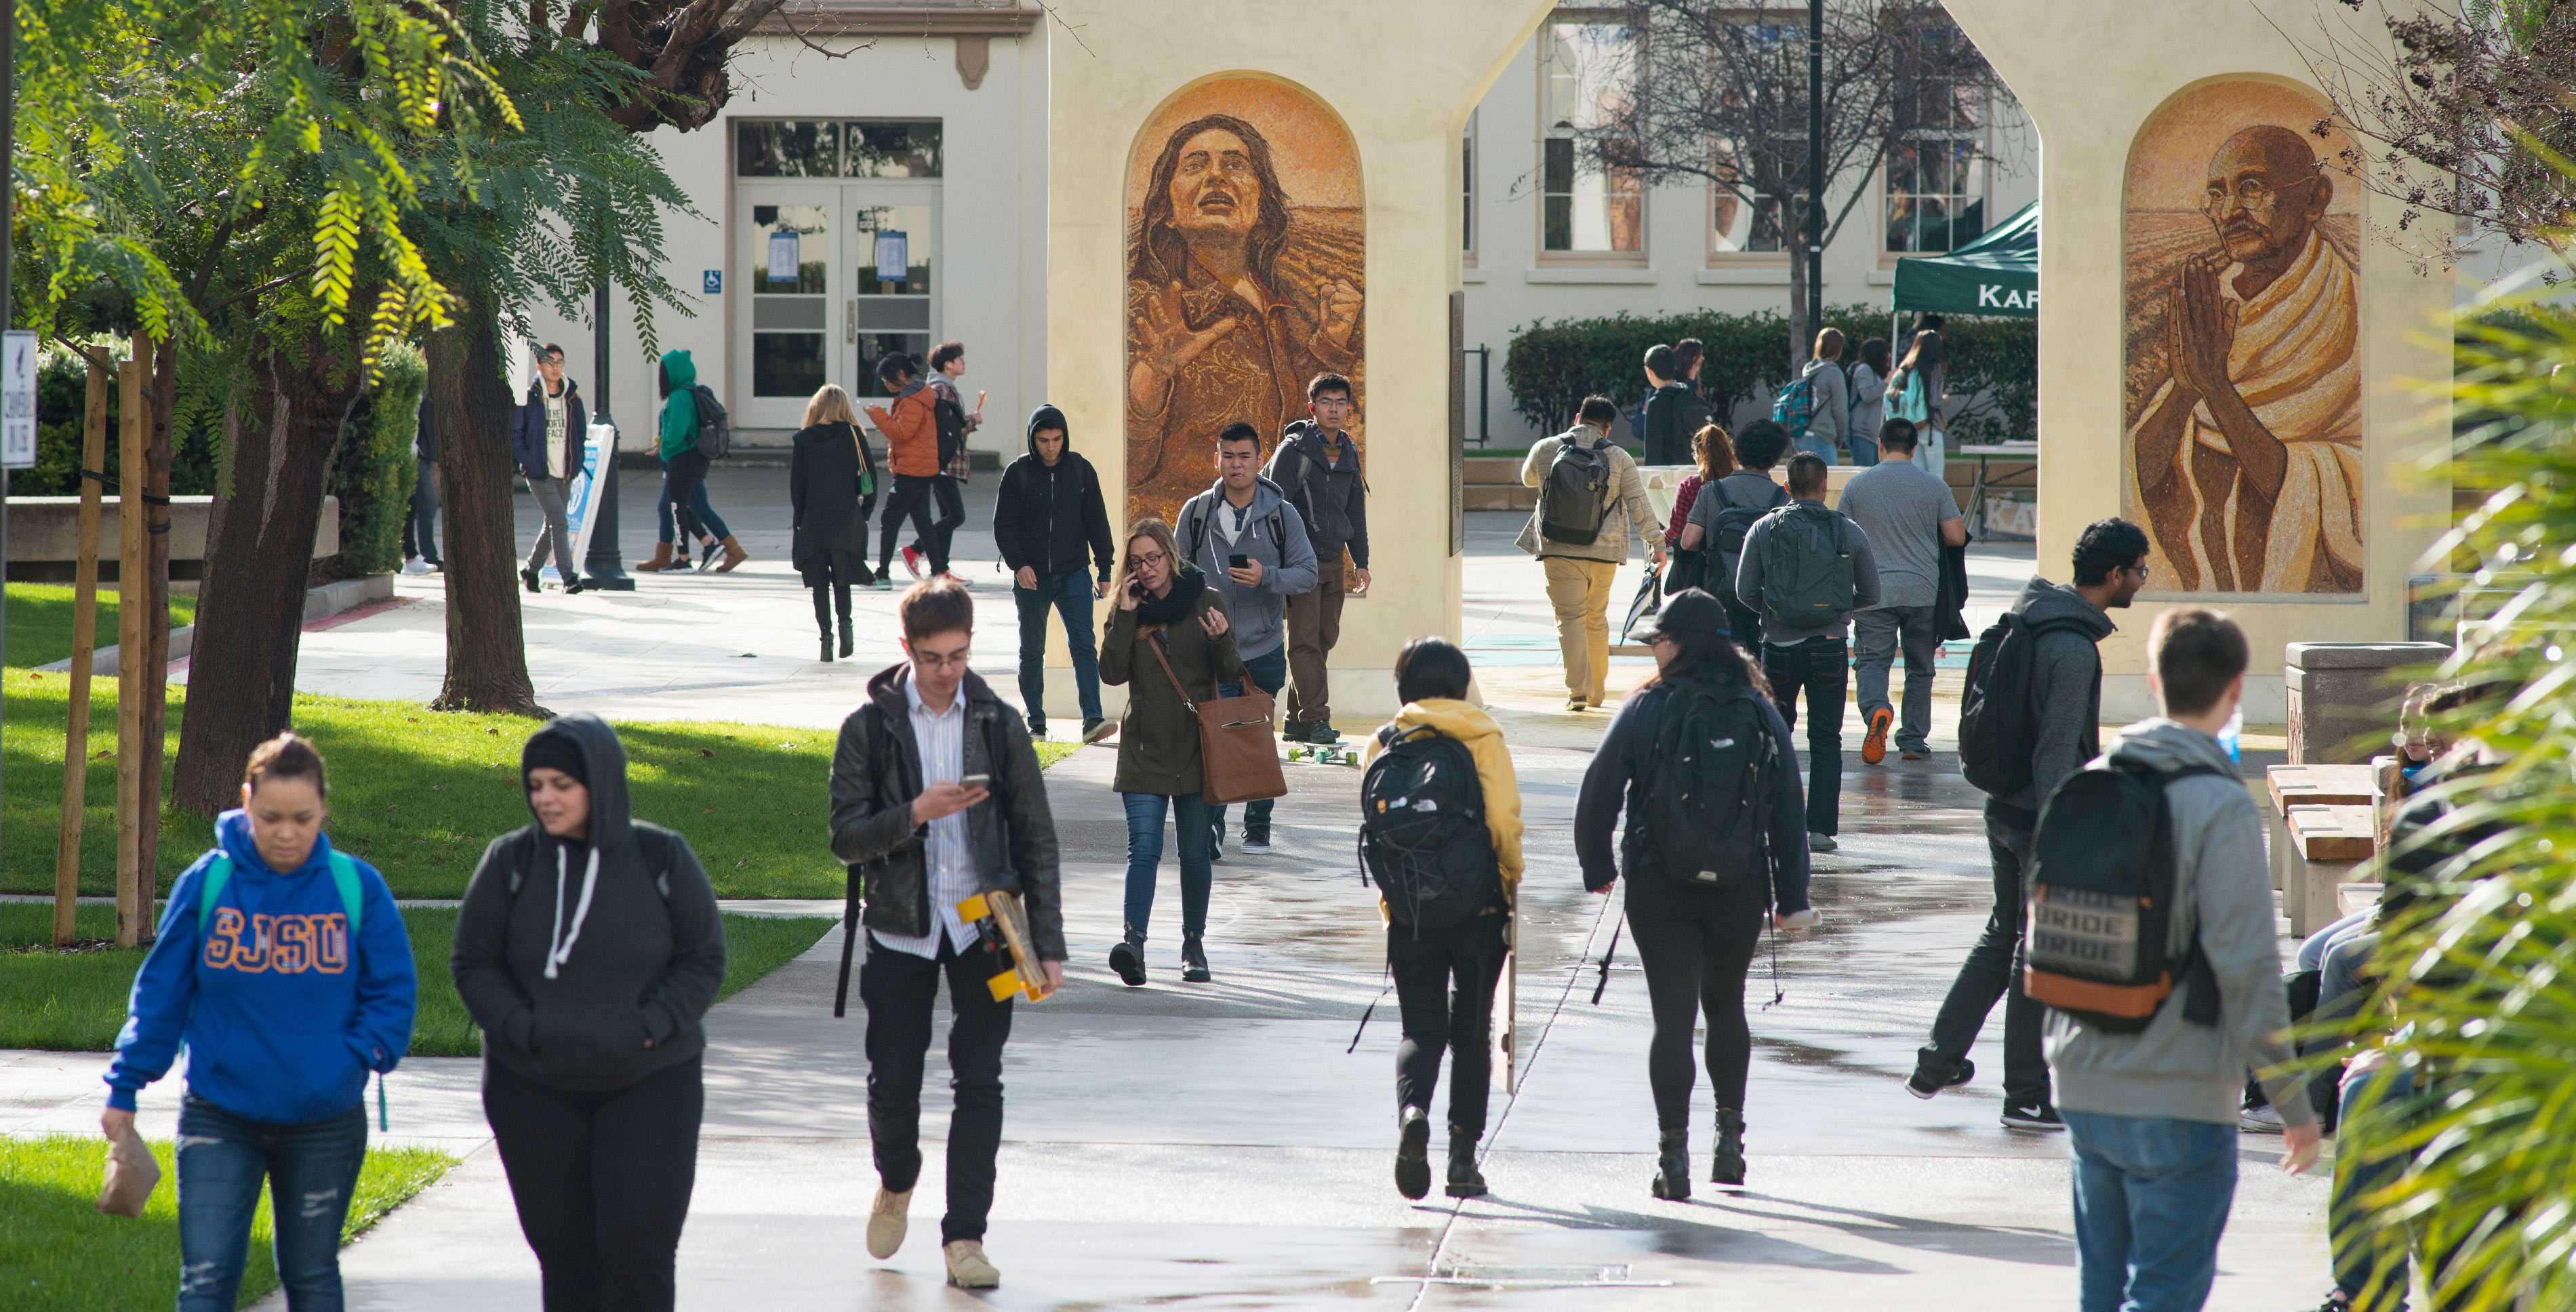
<box><xmin>484</xmin><ymin>1057</ymin><xmax>706</xmax><ymax>1312</ymax></box>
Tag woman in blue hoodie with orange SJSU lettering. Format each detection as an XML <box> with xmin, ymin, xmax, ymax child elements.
<box><xmin>98</xmin><ymin>734</ymin><xmax>415</xmax><ymax>1312</ymax></box>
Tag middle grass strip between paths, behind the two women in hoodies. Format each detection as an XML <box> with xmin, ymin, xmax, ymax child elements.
<box><xmin>0</xmin><ymin>902</ymin><xmax>840</xmax><ymax>1052</ymax></box>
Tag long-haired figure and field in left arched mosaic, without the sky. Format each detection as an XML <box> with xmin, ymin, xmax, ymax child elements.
<box><xmin>1126</xmin><ymin>113</ymin><xmax>1363</xmax><ymax>518</ymax></box>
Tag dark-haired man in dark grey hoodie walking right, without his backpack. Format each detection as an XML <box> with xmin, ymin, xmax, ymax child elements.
<box><xmin>1906</xmin><ymin>518</ymin><xmax>2146</xmax><ymax>1129</ymax></box>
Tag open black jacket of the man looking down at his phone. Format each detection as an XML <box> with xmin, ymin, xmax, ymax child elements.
<box><xmin>832</xmin><ymin>665</ymin><xmax>1064</xmax><ymax>961</ymax></box>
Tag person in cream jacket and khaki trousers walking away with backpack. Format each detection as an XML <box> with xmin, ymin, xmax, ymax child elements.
<box><xmin>1517</xmin><ymin>397</ymin><xmax>1664</xmax><ymax>711</ymax></box>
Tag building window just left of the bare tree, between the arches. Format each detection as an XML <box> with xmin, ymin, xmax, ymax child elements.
<box><xmin>1538</xmin><ymin>18</ymin><xmax>1646</xmax><ymax>263</ymax></box>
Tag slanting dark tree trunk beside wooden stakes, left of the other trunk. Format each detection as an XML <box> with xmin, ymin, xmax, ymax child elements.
<box><xmin>173</xmin><ymin>340</ymin><xmax>361</xmax><ymax>812</ymax></box>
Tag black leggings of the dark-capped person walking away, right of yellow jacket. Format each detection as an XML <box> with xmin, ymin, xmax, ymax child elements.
<box><xmin>1628</xmin><ymin>879</ymin><xmax>1770</xmax><ymax>1129</ymax></box>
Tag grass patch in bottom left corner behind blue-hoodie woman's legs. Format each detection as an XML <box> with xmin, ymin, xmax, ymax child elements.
<box><xmin>0</xmin><ymin>1134</ymin><xmax>456</xmax><ymax>1312</ymax></box>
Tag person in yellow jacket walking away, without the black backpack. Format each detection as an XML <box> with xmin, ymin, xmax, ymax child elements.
<box><xmin>1368</xmin><ymin>637</ymin><xmax>1523</xmax><ymax>1199</ymax></box>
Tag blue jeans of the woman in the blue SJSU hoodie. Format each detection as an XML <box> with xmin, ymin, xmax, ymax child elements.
<box><xmin>178</xmin><ymin>1093</ymin><xmax>366</xmax><ymax>1312</ymax></box>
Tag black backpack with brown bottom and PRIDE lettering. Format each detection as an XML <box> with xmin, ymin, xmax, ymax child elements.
<box><xmin>2022</xmin><ymin>763</ymin><xmax>2228</xmax><ymax>1033</ymax></box>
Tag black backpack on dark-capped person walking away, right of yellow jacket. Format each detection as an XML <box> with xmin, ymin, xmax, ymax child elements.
<box><xmin>1643</xmin><ymin>681</ymin><xmax>1780</xmax><ymax>890</ymax></box>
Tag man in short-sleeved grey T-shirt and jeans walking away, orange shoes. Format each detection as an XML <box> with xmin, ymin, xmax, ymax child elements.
<box><xmin>1842</xmin><ymin>420</ymin><xmax>1968</xmax><ymax>766</ymax></box>
